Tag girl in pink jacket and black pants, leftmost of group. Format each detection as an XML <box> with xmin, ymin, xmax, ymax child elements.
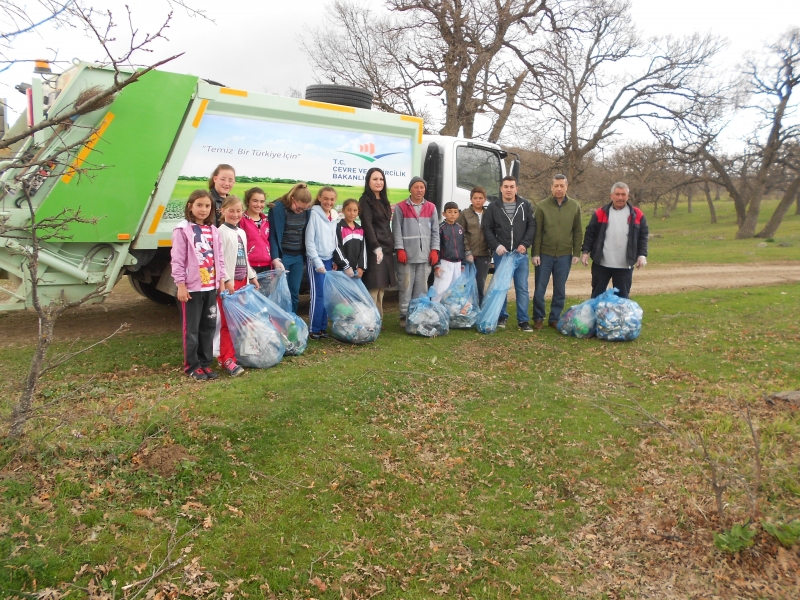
<box><xmin>171</xmin><ymin>190</ymin><xmax>226</xmax><ymax>381</ymax></box>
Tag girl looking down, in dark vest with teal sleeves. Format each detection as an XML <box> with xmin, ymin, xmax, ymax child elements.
<box><xmin>267</xmin><ymin>181</ymin><xmax>311</xmax><ymax>314</ymax></box>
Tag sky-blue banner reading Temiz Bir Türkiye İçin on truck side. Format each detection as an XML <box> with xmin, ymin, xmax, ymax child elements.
<box><xmin>180</xmin><ymin>115</ymin><xmax>412</xmax><ymax>189</ymax></box>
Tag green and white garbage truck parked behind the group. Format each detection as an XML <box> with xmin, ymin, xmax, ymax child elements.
<box><xmin>0</xmin><ymin>63</ymin><xmax>519</xmax><ymax>310</ymax></box>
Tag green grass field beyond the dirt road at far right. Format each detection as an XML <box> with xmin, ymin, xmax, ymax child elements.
<box><xmin>644</xmin><ymin>200</ymin><xmax>800</xmax><ymax>265</ymax></box>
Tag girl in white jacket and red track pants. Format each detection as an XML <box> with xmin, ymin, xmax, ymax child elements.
<box><xmin>217</xmin><ymin>196</ymin><xmax>258</xmax><ymax>377</ymax></box>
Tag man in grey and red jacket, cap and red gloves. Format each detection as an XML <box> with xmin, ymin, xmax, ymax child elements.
<box><xmin>392</xmin><ymin>177</ymin><xmax>439</xmax><ymax>327</ymax></box>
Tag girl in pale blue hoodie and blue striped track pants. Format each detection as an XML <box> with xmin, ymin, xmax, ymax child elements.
<box><xmin>306</xmin><ymin>185</ymin><xmax>353</xmax><ymax>340</ymax></box>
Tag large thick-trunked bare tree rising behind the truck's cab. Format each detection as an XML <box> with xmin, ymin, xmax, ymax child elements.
<box><xmin>306</xmin><ymin>0</ymin><xmax>551</xmax><ymax>141</ymax></box>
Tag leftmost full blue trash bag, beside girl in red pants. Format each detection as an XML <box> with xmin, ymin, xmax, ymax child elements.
<box><xmin>222</xmin><ymin>284</ymin><xmax>286</xmax><ymax>369</ymax></box>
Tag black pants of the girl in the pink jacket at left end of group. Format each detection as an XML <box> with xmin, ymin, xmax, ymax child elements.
<box><xmin>179</xmin><ymin>290</ymin><xmax>217</xmax><ymax>373</ymax></box>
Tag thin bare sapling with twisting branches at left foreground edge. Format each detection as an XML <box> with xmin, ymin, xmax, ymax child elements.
<box><xmin>0</xmin><ymin>0</ymin><xmax>202</xmax><ymax>438</ymax></box>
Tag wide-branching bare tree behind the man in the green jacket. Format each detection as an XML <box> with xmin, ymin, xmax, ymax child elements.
<box><xmin>518</xmin><ymin>0</ymin><xmax>720</xmax><ymax>184</ymax></box>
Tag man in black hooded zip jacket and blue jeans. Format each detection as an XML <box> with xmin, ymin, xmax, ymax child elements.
<box><xmin>481</xmin><ymin>175</ymin><xmax>536</xmax><ymax>331</ymax></box>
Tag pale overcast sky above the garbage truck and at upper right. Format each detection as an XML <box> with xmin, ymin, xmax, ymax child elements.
<box><xmin>0</xmin><ymin>0</ymin><xmax>800</xmax><ymax>130</ymax></box>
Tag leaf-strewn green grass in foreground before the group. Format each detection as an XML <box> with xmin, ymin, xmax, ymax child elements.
<box><xmin>0</xmin><ymin>285</ymin><xmax>800</xmax><ymax>599</ymax></box>
